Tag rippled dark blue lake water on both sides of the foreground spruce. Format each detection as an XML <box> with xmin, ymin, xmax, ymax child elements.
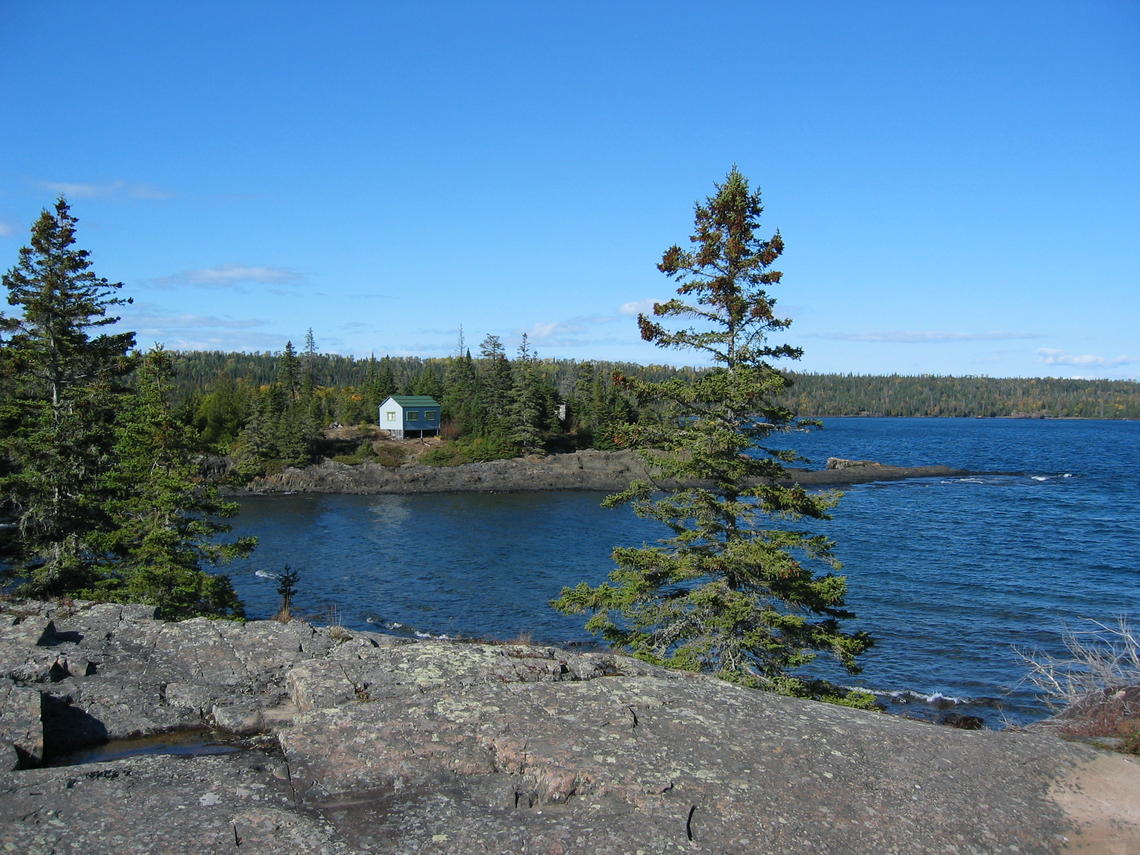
<box><xmin>217</xmin><ymin>418</ymin><xmax>1140</xmax><ymax>726</ymax></box>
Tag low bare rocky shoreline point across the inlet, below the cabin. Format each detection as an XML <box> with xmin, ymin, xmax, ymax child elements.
<box><xmin>240</xmin><ymin>450</ymin><xmax>970</xmax><ymax>494</ymax></box>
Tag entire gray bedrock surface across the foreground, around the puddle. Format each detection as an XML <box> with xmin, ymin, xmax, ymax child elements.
<box><xmin>0</xmin><ymin>603</ymin><xmax>1140</xmax><ymax>855</ymax></box>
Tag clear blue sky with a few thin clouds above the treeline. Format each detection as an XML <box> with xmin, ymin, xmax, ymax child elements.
<box><xmin>0</xmin><ymin>0</ymin><xmax>1140</xmax><ymax>378</ymax></box>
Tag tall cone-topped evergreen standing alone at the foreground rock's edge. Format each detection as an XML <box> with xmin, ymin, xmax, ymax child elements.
<box><xmin>554</xmin><ymin>168</ymin><xmax>871</xmax><ymax>705</ymax></box>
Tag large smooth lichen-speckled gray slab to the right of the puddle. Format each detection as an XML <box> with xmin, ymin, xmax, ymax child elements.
<box><xmin>280</xmin><ymin>677</ymin><xmax>1112</xmax><ymax>854</ymax></box>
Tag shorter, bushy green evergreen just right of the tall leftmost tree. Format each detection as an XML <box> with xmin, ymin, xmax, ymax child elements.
<box><xmin>98</xmin><ymin>348</ymin><xmax>257</xmax><ymax>619</ymax></box>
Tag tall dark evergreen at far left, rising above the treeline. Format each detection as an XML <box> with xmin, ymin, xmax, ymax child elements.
<box><xmin>0</xmin><ymin>197</ymin><xmax>135</xmax><ymax>596</ymax></box>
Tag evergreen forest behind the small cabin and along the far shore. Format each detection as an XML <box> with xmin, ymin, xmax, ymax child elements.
<box><xmin>166</xmin><ymin>342</ymin><xmax>1140</xmax><ymax>467</ymax></box>
